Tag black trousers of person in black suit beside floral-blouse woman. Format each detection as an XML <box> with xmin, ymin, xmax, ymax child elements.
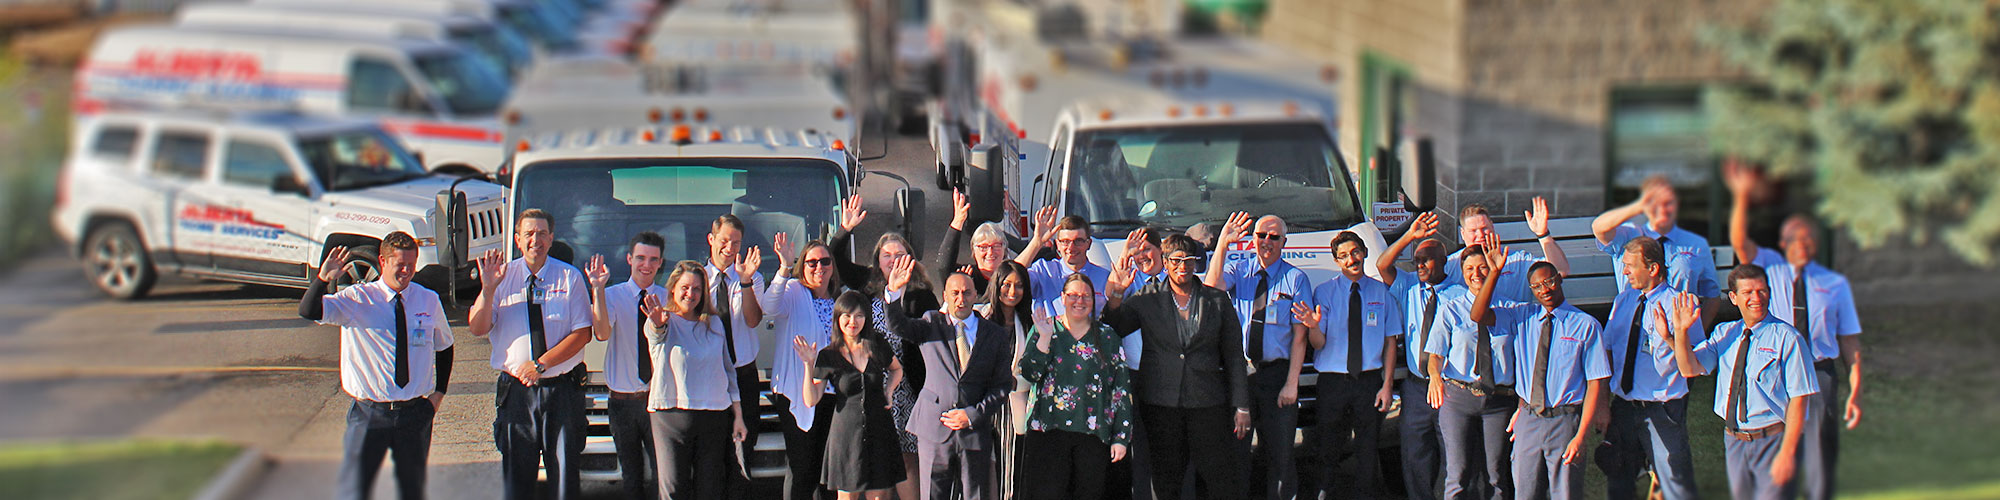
<box><xmin>1140</xmin><ymin>404</ymin><xmax>1244</xmax><ymax>498</ymax></box>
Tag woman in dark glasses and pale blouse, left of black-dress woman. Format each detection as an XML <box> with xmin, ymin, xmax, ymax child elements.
<box><xmin>762</xmin><ymin>232</ymin><xmax>846</xmax><ymax>500</ymax></box>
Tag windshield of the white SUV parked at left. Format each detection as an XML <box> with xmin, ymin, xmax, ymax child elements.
<box><xmin>298</xmin><ymin>128</ymin><xmax>426</xmax><ymax>192</ymax></box>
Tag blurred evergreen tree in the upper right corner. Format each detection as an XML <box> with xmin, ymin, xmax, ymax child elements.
<box><xmin>1702</xmin><ymin>0</ymin><xmax>2000</xmax><ymax>266</ymax></box>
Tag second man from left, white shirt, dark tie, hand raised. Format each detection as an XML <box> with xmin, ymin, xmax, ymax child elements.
<box><xmin>466</xmin><ymin>208</ymin><xmax>592</xmax><ymax>498</ymax></box>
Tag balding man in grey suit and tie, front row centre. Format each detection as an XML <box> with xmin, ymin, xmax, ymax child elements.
<box><xmin>886</xmin><ymin>272</ymin><xmax>1014</xmax><ymax>500</ymax></box>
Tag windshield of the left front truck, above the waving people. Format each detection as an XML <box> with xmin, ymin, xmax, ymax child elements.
<box><xmin>514</xmin><ymin>158</ymin><xmax>842</xmax><ymax>276</ymax></box>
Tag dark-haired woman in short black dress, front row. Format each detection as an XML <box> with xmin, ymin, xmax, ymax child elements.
<box><xmin>792</xmin><ymin>290</ymin><xmax>904</xmax><ymax>500</ymax></box>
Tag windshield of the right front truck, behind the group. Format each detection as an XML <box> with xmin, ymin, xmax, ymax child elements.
<box><xmin>1064</xmin><ymin>122</ymin><xmax>1362</xmax><ymax>234</ymax></box>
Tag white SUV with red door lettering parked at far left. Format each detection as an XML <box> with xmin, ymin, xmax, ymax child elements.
<box><xmin>52</xmin><ymin>112</ymin><xmax>506</xmax><ymax>298</ymax></box>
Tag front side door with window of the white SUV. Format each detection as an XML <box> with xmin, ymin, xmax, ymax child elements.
<box><xmin>214</xmin><ymin>136</ymin><xmax>316</xmax><ymax>278</ymax></box>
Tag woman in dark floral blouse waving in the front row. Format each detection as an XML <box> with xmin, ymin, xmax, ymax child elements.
<box><xmin>1018</xmin><ymin>272</ymin><xmax>1132</xmax><ymax>500</ymax></box>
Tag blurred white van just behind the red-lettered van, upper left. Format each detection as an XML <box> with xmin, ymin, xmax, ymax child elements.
<box><xmin>174</xmin><ymin>4</ymin><xmax>534</xmax><ymax>80</ymax></box>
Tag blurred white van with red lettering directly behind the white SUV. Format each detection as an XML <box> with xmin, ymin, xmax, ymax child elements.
<box><xmin>74</xmin><ymin>26</ymin><xmax>508</xmax><ymax>174</ymax></box>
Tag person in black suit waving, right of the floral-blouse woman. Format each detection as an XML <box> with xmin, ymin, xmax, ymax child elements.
<box><xmin>1104</xmin><ymin>234</ymin><xmax>1250</xmax><ymax>498</ymax></box>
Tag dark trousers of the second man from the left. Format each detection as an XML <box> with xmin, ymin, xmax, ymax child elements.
<box><xmin>494</xmin><ymin>374</ymin><xmax>584</xmax><ymax>500</ymax></box>
